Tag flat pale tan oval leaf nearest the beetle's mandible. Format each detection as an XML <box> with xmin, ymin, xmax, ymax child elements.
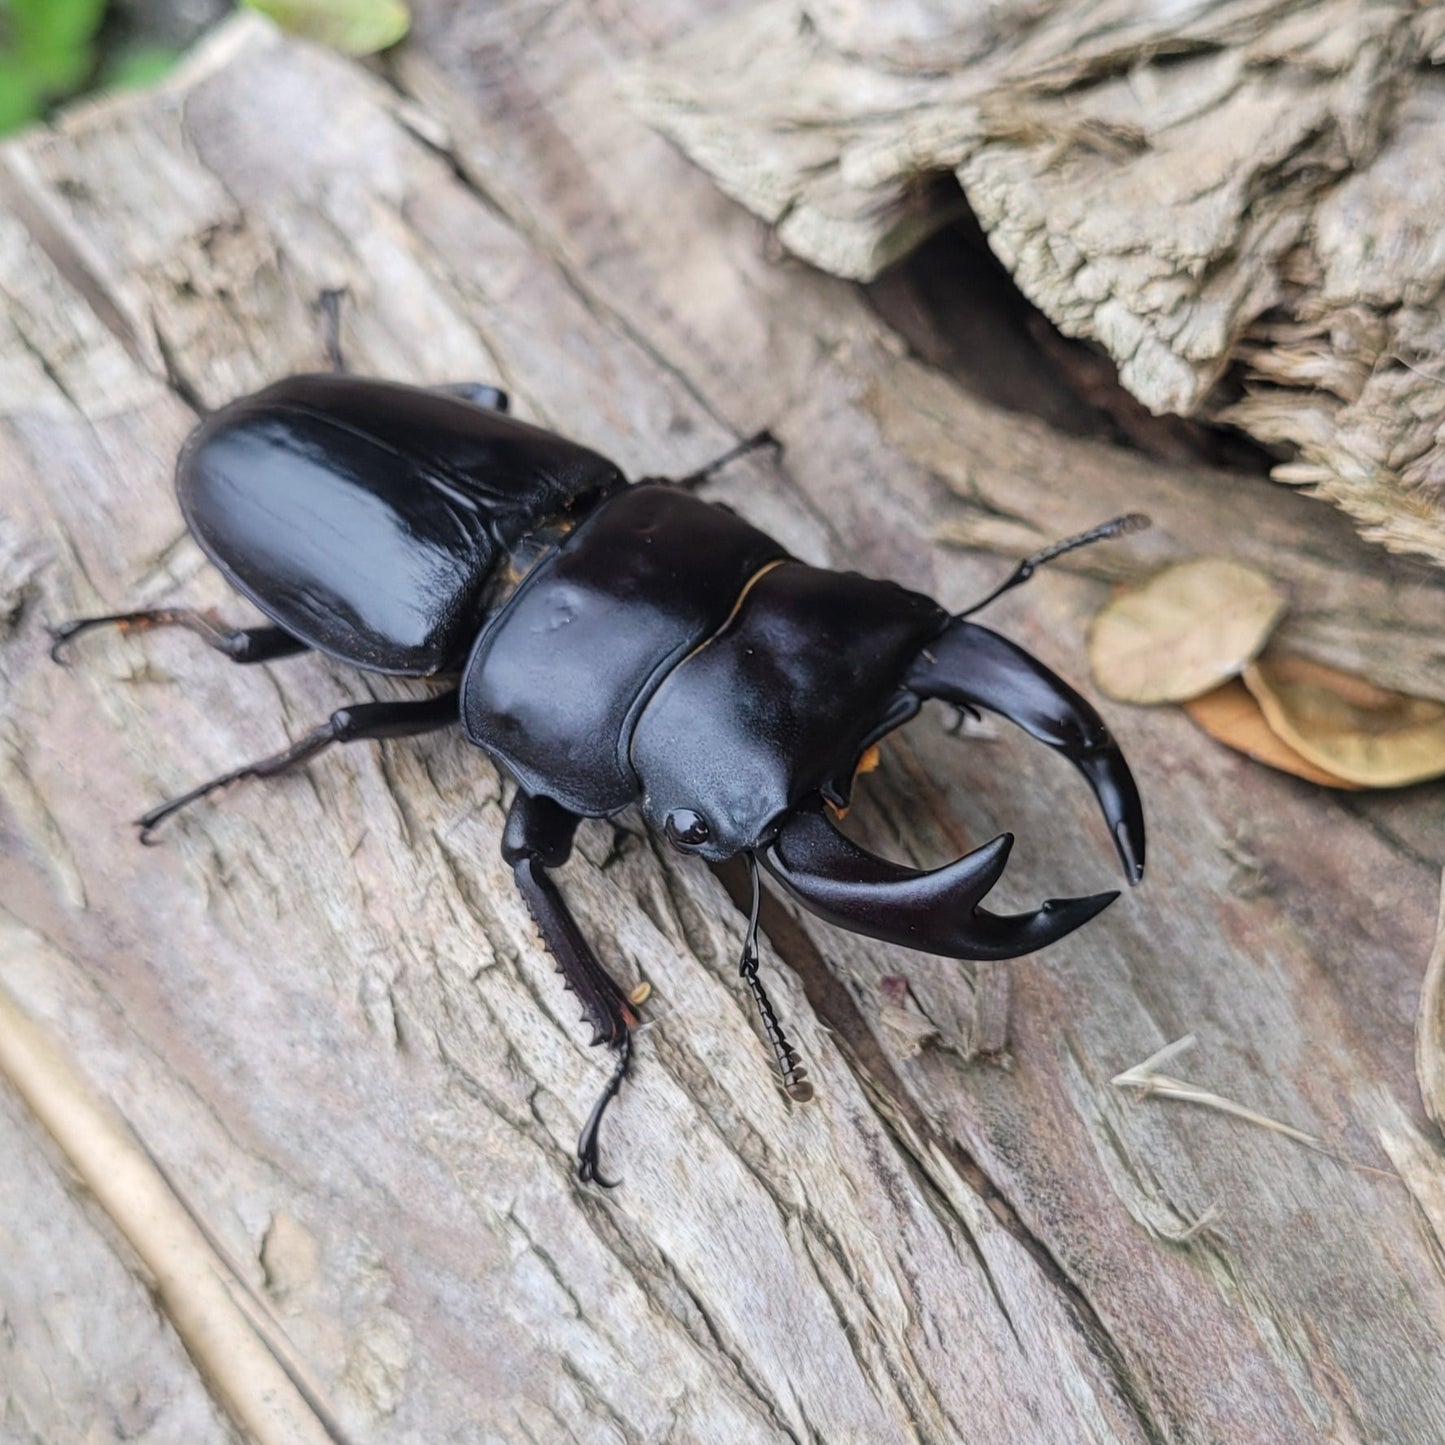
<box><xmin>1088</xmin><ymin>558</ymin><xmax>1285</xmax><ymax>702</ymax></box>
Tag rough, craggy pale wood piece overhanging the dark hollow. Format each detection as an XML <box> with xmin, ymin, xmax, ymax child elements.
<box><xmin>630</xmin><ymin>0</ymin><xmax>1445</xmax><ymax>562</ymax></box>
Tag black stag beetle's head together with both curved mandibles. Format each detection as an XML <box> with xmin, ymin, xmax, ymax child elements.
<box><xmin>629</xmin><ymin>549</ymin><xmax>1144</xmax><ymax>958</ymax></box>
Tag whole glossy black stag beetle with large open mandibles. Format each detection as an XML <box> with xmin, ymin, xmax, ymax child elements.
<box><xmin>53</xmin><ymin>376</ymin><xmax>1144</xmax><ymax>1183</ymax></box>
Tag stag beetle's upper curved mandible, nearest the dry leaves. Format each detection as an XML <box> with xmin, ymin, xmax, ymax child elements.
<box><xmin>903</xmin><ymin>617</ymin><xmax>1144</xmax><ymax>883</ymax></box>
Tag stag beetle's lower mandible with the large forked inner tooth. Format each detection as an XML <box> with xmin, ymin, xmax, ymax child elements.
<box><xmin>760</xmin><ymin>811</ymin><xmax>1118</xmax><ymax>958</ymax></box>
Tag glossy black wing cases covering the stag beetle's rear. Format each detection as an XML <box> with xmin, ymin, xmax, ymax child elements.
<box><xmin>176</xmin><ymin>376</ymin><xmax>620</xmax><ymax>676</ymax></box>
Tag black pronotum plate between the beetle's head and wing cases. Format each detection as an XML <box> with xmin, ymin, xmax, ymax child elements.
<box><xmin>462</xmin><ymin>484</ymin><xmax>788</xmax><ymax>816</ymax></box>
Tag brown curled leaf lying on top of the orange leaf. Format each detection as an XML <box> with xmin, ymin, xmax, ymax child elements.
<box><xmin>1244</xmin><ymin>657</ymin><xmax>1445</xmax><ymax>788</ymax></box>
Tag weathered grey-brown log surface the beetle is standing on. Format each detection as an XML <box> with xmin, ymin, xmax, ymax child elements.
<box><xmin>0</xmin><ymin>14</ymin><xmax>1445</xmax><ymax>1442</ymax></box>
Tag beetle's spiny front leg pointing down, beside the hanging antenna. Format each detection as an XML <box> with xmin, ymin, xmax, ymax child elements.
<box><xmin>501</xmin><ymin>788</ymin><xmax>640</xmax><ymax>1189</ymax></box>
